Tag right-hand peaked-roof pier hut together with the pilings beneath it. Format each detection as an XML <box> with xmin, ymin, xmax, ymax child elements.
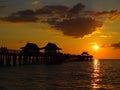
<box><xmin>41</xmin><ymin>43</ymin><xmax>63</xmax><ymax>64</ymax></box>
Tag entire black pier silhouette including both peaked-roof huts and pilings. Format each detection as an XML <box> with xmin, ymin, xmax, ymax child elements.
<box><xmin>0</xmin><ymin>43</ymin><xmax>93</xmax><ymax>66</ymax></box>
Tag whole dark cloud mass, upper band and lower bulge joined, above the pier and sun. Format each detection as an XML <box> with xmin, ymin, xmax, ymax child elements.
<box><xmin>0</xmin><ymin>3</ymin><xmax>118</xmax><ymax>38</ymax></box>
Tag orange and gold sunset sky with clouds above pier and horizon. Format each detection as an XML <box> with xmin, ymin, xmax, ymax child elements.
<box><xmin>0</xmin><ymin>0</ymin><xmax>120</xmax><ymax>59</ymax></box>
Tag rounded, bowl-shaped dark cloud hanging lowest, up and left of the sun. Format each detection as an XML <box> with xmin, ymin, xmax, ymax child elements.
<box><xmin>49</xmin><ymin>17</ymin><xmax>102</xmax><ymax>38</ymax></box>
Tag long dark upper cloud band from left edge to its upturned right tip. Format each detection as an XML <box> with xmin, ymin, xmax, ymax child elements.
<box><xmin>2</xmin><ymin>3</ymin><xmax>85</xmax><ymax>22</ymax></box>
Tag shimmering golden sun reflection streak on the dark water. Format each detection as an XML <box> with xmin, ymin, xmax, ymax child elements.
<box><xmin>91</xmin><ymin>59</ymin><xmax>102</xmax><ymax>89</ymax></box>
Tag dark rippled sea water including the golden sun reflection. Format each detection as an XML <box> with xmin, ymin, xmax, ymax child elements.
<box><xmin>0</xmin><ymin>60</ymin><xmax>120</xmax><ymax>90</ymax></box>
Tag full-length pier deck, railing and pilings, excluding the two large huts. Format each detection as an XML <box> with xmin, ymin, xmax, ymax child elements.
<box><xmin>0</xmin><ymin>48</ymin><xmax>93</xmax><ymax>66</ymax></box>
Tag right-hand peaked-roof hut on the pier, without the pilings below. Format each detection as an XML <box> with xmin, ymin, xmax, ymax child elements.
<box><xmin>42</xmin><ymin>43</ymin><xmax>61</xmax><ymax>55</ymax></box>
